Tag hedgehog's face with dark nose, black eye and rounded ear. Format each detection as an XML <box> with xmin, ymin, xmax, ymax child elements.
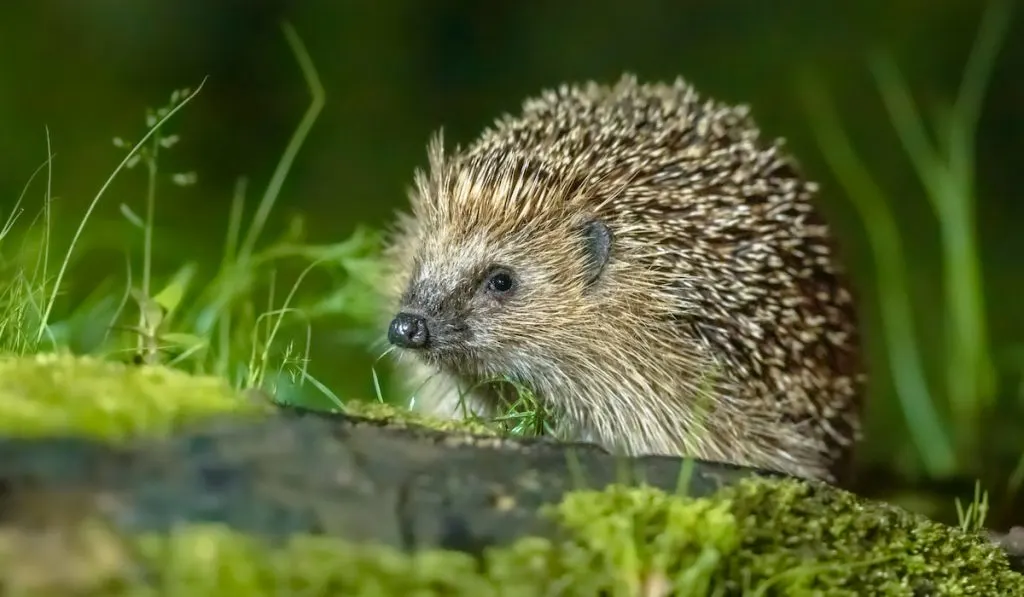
<box><xmin>388</xmin><ymin>216</ymin><xmax>611</xmax><ymax>378</ymax></box>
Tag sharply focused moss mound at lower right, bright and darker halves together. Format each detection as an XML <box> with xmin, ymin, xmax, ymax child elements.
<box><xmin>490</xmin><ymin>479</ymin><xmax>1024</xmax><ymax>596</ymax></box>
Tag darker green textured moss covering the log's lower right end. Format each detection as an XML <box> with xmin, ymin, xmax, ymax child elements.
<box><xmin>720</xmin><ymin>479</ymin><xmax>1024</xmax><ymax>596</ymax></box>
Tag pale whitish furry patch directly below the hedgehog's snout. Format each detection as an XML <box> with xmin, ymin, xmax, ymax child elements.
<box><xmin>396</xmin><ymin>359</ymin><xmax>492</xmax><ymax>419</ymax></box>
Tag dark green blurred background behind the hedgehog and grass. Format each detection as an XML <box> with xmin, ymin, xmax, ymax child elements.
<box><xmin>0</xmin><ymin>0</ymin><xmax>1024</xmax><ymax>521</ymax></box>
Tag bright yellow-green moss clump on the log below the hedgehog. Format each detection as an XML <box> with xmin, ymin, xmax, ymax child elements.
<box><xmin>486</xmin><ymin>485</ymin><xmax>741</xmax><ymax>596</ymax></box>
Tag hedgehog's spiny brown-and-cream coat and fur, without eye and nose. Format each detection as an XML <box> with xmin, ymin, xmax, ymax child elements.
<box><xmin>386</xmin><ymin>75</ymin><xmax>864</xmax><ymax>480</ymax></box>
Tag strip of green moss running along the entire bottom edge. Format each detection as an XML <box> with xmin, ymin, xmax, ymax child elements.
<box><xmin>6</xmin><ymin>480</ymin><xmax>1024</xmax><ymax>597</ymax></box>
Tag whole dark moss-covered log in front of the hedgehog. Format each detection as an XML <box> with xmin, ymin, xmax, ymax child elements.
<box><xmin>0</xmin><ymin>356</ymin><xmax>1024</xmax><ymax>597</ymax></box>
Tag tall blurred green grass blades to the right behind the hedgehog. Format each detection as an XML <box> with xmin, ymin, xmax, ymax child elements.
<box><xmin>804</xmin><ymin>0</ymin><xmax>1024</xmax><ymax>512</ymax></box>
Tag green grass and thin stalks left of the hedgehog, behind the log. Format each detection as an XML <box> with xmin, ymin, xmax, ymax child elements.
<box><xmin>0</xmin><ymin>20</ymin><xmax>377</xmax><ymax>404</ymax></box>
